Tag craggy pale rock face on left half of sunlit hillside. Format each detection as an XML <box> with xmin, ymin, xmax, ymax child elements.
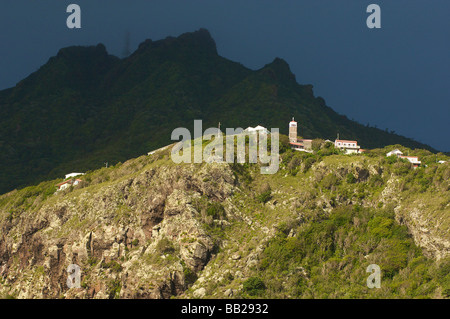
<box><xmin>0</xmin><ymin>160</ymin><xmax>235</xmax><ymax>298</ymax></box>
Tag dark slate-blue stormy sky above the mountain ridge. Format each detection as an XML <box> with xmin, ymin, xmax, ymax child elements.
<box><xmin>0</xmin><ymin>0</ymin><xmax>450</xmax><ymax>151</ymax></box>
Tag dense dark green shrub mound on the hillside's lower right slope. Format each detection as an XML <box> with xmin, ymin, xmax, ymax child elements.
<box><xmin>260</xmin><ymin>206</ymin><xmax>439</xmax><ymax>298</ymax></box>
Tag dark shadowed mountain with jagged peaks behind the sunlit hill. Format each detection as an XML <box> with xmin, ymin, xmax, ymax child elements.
<box><xmin>0</xmin><ymin>29</ymin><xmax>433</xmax><ymax>193</ymax></box>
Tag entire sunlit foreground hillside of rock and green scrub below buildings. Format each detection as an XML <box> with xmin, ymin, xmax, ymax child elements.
<box><xmin>0</xmin><ymin>149</ymin><xmax>450</xmax><ymax>298</ymax></box>
